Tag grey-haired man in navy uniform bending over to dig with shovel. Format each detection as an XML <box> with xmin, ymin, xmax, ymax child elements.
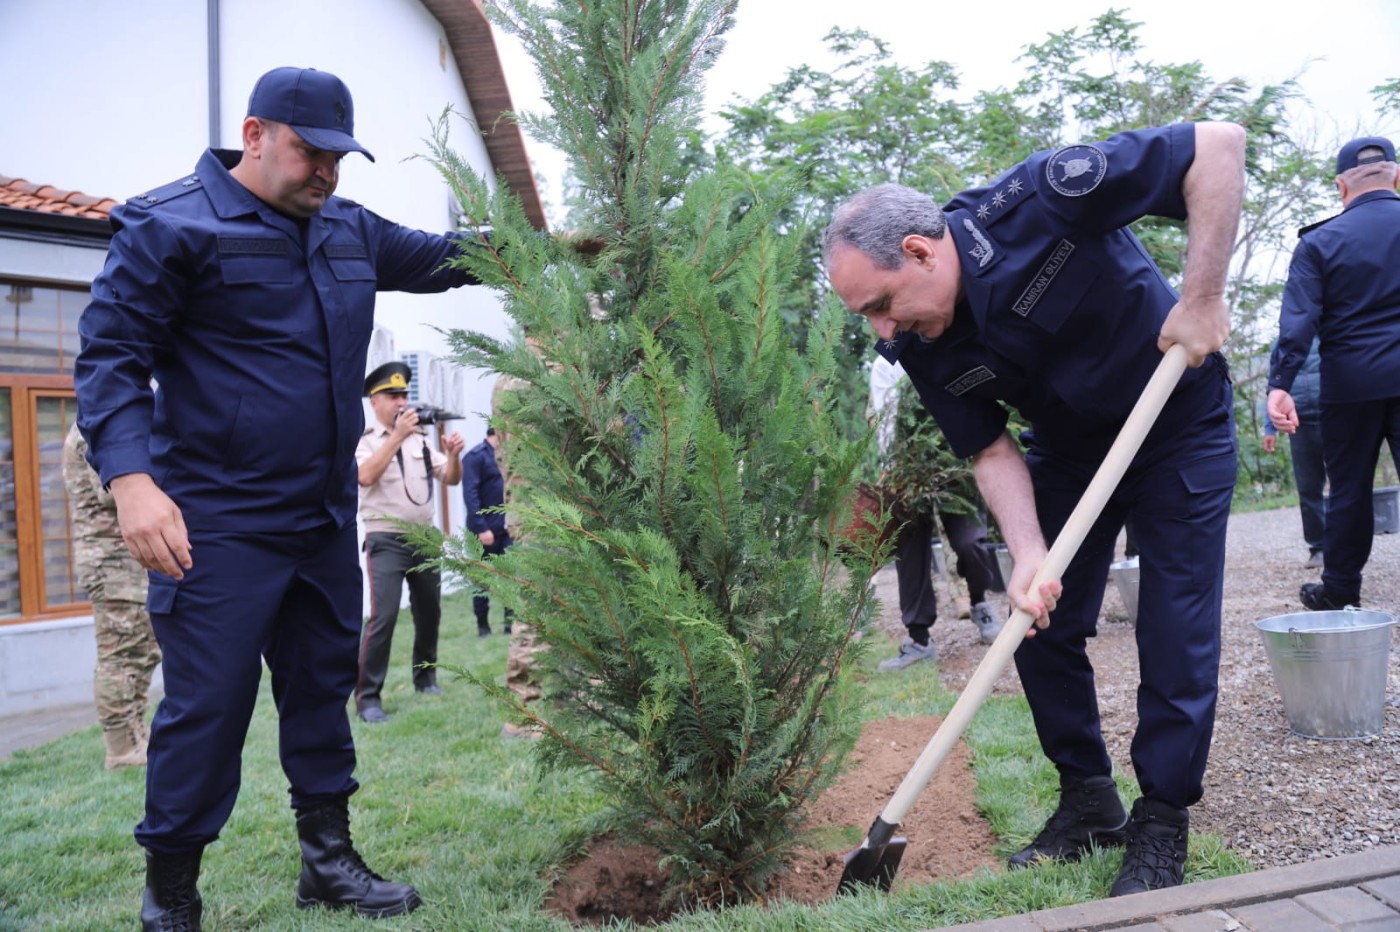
<box><xmin>823</xmin><ymin>123</ymin><xmax>1245</xmax><ymax>896</ymax></box>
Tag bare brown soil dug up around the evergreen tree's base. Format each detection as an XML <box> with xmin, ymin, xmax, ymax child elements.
<box><xmin>545</xmin><ymin>715</ymin><xmax>998</xmax><ymax>925</ymax></box>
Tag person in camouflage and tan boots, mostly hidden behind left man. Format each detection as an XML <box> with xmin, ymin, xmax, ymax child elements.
<box><xmin>63</xmin><ymin>424</ymin><xmax>161</xmax><ymax>770</ymax></box>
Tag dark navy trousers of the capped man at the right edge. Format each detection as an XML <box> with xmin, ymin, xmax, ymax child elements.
<box><xmin>1322</xmin><ymin>397</ymin><xmax>1400</xmax><ymax>599</ymax></box>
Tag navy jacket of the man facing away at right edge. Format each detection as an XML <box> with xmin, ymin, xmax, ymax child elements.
<box><xmin>1268</xmin><ymin>190</ymin><xmax>1400</xmax><ymax>404</ymax></box>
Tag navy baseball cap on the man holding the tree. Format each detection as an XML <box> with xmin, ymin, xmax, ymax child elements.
<box><xmin>248</xmin><ymin>67</ymin><xmax>374</xmax><ymax>162</ymax></box>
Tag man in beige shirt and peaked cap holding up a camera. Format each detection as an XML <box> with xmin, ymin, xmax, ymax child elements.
<box><xmin>354</xmin><ymin>362</ymin><xmax>465</xmax><ymax>723</ymax></box>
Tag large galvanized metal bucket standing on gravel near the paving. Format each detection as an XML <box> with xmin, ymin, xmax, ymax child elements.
<box><xmin>1254</xmin><ymin>609</ymin><xmax>1396</xmax><ymax>739</ymax></box>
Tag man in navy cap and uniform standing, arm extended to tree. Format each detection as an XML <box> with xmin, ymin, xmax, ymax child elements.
<box><xmin>74</xmin><ymin>67</ymin><xmax>492</xmax><ymax>929</ymax></box>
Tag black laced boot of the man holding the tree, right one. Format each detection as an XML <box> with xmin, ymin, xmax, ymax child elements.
<box><xmin>297</xmin><ymin>799</ymin><xmax>423</xmax><ymax>919</ymax></box>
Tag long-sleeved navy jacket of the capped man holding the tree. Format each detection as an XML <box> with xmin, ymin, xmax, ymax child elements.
<box><xmin>74</xmin><ymin>150</ymin><xmax>476</xmax><ymax>532</ymax></box>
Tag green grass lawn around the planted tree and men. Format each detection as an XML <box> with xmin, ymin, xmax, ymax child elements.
<box><xmin>0</xmin><ymin>593</ymin><xmax>1249</xmax><ymax>932</ymax></box>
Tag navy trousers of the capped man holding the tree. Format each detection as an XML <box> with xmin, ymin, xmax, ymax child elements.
<box><xmin>136</xmin><ymin>522</ymin><xmax>363</xmax><ymax>854</ymax></box>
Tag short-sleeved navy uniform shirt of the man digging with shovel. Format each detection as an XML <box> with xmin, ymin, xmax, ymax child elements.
<box><xmin>878</xmin><ymin>123</ymin><xmax>1226</xmax><ymax>463</ymax></box>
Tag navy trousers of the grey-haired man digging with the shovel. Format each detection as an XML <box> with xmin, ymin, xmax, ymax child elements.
<box><xmin>1016</xmin><ymin>379</ymin><xmax>1236</xmax><ymax>807</ymax></box>
